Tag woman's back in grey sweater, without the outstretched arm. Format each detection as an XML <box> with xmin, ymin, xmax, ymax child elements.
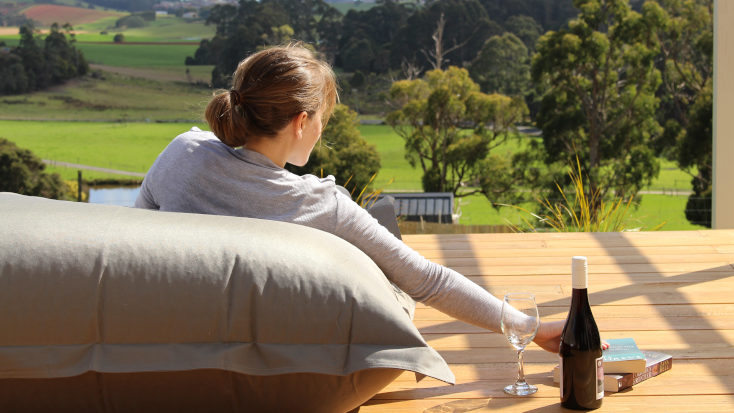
<box><xmin>135</xmin><ymin>127</ymin><xmax>337</xmax><ymax>233</ymax></box>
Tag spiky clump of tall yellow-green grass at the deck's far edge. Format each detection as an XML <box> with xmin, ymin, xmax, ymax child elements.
<box><xmin>497</xmin><ymin>156</ymin><xmax>666</xmax><ymax>232</ymax></box>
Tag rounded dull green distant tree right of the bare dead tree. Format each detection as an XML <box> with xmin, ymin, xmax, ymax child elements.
<box><xmin>469</xmin><ymin>33</ymin><xmax>530</xmax><ymax>96</ymax></box>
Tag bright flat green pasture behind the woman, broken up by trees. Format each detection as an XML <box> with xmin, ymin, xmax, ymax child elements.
<box><xmin>0</xmin><ymin>121</ymin><xmax>703</xmax><ymax>231</ymax></box>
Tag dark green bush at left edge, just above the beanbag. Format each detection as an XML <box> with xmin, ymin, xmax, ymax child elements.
<box><xmin>0</xmin><ymin>138</ymin><xmax>65</xmax><ymax>199</ymax></box>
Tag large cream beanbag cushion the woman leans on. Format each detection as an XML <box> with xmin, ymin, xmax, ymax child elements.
<box><xmin>0</xmin><ymin>193</ymin><xmax>454</xmax><ymax>412</ymax></box>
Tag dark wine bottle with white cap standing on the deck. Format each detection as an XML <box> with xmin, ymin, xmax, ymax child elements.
<box><xmin>560</xmin><ymin>257</ymin><xmax>604</xmax><ymax>410</ymax></box>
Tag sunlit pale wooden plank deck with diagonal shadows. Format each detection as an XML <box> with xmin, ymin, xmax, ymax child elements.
<box><xmin>360</xmin><ymin>230</ymin><xmax>734</xmax><ymax>413</ymax></box>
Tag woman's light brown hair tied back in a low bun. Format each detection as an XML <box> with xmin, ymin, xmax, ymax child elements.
<box><xmin>204</xmin><ymin>42</ymin><xmax>339</xmax><ymax>148</ymax></box>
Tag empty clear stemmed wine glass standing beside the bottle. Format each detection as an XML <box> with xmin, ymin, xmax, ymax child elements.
<box><xmin>502</xmin><ymin>293</ymin><xmax>540</xmax><ymax>396</ymax></box>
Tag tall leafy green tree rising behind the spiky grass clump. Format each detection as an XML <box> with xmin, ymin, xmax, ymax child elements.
<box><xmin>532</xmin><ymin>0</ymin><xmax>665</xmax><ymax>197</ymax></box>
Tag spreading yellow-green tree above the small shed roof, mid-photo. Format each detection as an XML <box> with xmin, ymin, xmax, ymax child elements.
<box><xmin>387</xmin><ymin>66</ymin><xmax>528</xmax><ymax>198</ymax></box>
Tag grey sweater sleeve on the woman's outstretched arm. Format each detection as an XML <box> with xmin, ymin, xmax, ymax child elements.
<box><xmin>334</xmin><ymin>191</ymin><xmax>528</xmax><ymax>333</ymax></box>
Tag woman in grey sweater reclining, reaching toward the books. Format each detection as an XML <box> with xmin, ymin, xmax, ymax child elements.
<box><xmin>135</xmin><ymin>44</ymin><xmax>564</xmax><ymax>353</ymax></box>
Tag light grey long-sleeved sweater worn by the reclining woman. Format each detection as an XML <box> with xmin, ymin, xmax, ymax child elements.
<box><xmin>135</xmin><ymin>127</ymin><xmax>522</xmax><ymax>332</ymax></box>
